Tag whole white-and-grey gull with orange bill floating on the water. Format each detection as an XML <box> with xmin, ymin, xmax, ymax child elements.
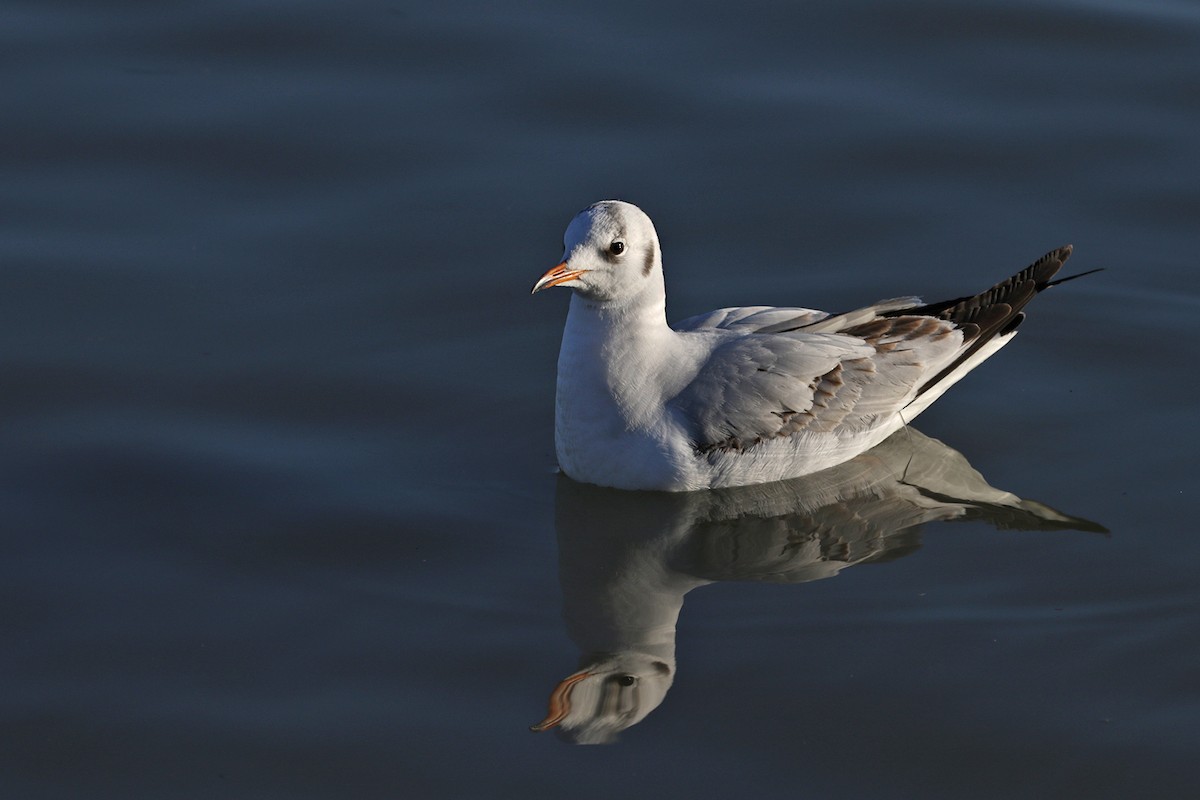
<box><xmin>533</xmin><ymin>200</ymin><xmax>1096</xmax><ymax>492</ymax></box>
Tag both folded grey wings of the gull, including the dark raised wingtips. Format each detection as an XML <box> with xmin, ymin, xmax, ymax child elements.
<box><xmin>671</xmin><ymin>245</ymin><xmax>1080</xmax><ymax>453</ymax></box>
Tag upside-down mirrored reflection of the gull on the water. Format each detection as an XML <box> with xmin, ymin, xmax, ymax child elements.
<box><xmin>532</xmin><ymin>428</ymin><xmax>1106</xmax><ymax>744</ymax></box>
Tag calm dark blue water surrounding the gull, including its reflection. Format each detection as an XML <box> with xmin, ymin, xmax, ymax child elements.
<box><xmin>0</xmin><ymin>0</ymin><xmax>1200</xmax><ymax>799</ymax></box>
